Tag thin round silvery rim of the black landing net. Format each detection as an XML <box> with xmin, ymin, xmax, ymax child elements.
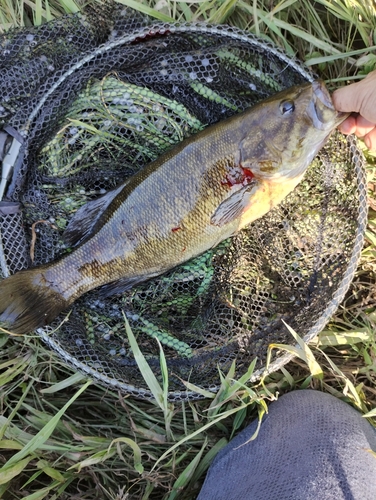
<box><xmin>0</xmin><ymin>18</ymin><xmax>368</xmax><ymax>401</ymax></box>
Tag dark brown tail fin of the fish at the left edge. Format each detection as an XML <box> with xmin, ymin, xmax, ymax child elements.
<box><xmin>0</xmin><ymin>267</ymin><xmax>70</xmax><ymax>334</ymax></box>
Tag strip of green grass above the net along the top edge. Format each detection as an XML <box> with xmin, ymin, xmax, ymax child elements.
<box><xmin>0</xmin><ymin>0</ymin><xmax>376</xmax><ymax>81</ymax></box>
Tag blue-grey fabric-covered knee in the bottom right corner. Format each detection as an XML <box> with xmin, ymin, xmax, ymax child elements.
<box><xmin>198</xmin><ymin>390</ymin><xmax>376</xmax><ymax>500</ymax></box>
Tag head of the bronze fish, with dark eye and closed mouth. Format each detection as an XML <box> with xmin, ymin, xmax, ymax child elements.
<box><xmin>240</xmin><ymin>80</ymin><xmax>349</xmax><ymax>179</ymax></box>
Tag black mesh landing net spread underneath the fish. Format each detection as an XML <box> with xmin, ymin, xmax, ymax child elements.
<box><xmin>0</xmin><ymin>7</ymin><xmax>367</xmax><ymax>400</ymax></box>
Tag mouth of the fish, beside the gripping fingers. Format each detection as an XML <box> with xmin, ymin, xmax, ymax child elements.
<box><xmin>307</xmin><ymin>80</ymin><xmax>350</xmax><ymax>131</ymax></box>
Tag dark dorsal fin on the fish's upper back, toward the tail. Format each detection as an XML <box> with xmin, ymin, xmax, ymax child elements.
<box><xmin>63</xmin><ymin>183</ymin><xmax>125</xmax><ymax>246</ymax></box>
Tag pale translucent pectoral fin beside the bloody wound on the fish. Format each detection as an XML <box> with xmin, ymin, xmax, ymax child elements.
<box><xmin>210</xmin><ymin>180</ymin><xmax>258</xmax><ymax>227</ymax></box>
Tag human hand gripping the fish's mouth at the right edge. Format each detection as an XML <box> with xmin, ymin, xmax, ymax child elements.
<box><xmin>332</xmin><ymin>71</ymin><xmax>376</xmax><ymax>151</ymax></box>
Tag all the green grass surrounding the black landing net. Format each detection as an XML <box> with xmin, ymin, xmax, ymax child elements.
<box><xmin>0</xmin><ymin>0</ymin><xmax>376</xmax><ymax>500</ymax></box>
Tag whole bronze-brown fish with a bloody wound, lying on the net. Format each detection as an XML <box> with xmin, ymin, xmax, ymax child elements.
<box><xmin>0</xmin><ymin>82</ymin><xmax>347</xmax><ymax>333</ymax></box>
